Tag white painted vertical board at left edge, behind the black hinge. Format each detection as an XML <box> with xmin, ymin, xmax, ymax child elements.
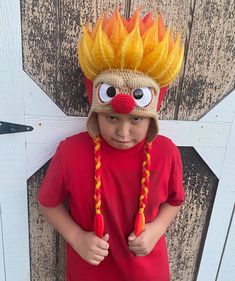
<box><xmin>0</xmin><ymin>0</ymin><xmax>30</xmax><ymax>281</ymax></box>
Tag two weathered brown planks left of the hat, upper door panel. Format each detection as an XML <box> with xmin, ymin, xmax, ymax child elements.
<box><xmin>21</xmin><ymin>0</ymin><xmax>129</xmax><ymax>116</ymax></box>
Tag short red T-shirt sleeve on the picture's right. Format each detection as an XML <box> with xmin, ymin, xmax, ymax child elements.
<box><xmin>166</xmin><ymin>146</ymin><xmax>185</xmax><ymax>206</ymax></box>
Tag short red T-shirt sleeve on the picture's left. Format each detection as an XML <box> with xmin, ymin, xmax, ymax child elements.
<box><xmin>38</xmin><ymin>141</ymin><xmax>67</xmax><ymax>207</ymax></box>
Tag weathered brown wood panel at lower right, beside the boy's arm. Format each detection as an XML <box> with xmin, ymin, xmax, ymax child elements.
<box><xmin>167</xmin><ymin>147</ymin><xmax>218</xmax><ymax>281</ymax></box>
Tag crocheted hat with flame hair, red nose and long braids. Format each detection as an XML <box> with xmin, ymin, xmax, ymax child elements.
<box><xmin>78</xmin><ymin>9</ymin><xmax>184</xmax><ymax>237</ymax></box>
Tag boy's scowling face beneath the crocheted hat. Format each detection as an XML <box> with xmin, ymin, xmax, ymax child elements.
<box><xmin>98</xmin><ymin>113</ymin><xmax>150</xmax><ymax>149</ymax></box>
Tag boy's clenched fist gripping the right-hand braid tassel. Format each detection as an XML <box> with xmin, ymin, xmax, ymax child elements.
<box><xmin>128</xmin><ymin>223</ymin><xmax>165</xmax><ymax>256</ymax></box>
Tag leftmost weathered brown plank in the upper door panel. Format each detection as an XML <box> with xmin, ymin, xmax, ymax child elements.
<box><xmin>20</xmin><ymin>0</ymin><xmax>58</xmax><ymax>104</ymax></box>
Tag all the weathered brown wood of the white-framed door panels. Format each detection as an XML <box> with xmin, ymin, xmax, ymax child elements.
<box><xmin>21</xmin><ymin>0</ymin><xmax>235</xmax><ymax>281</ymax></box>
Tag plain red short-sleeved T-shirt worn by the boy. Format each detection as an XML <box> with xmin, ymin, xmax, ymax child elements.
<box><xmin>39</xmin><ymin>132</ymin><xmax>184</xmax><ymax>281</ymax></box>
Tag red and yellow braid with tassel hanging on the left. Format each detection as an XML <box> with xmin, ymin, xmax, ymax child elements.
<box><xmin>94</xmin><ymin>137</ymin><xmax>104</xmax><ymax>238</ymax></box>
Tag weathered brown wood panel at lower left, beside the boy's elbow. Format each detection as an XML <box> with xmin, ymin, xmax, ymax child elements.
<box><xmin>28</xmin><ymin>162</ymin><xmax>59</xmax><ymax>281</ymax></box>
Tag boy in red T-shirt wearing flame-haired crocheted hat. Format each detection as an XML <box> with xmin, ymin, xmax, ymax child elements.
<box><xmin>38</xmin><ymin>7</ymin><xmax>184</xmax><ymax>281</ymax></box>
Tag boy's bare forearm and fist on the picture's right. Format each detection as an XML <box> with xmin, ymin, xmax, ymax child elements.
<box><xmin>128</xmin><ymin>203</ymin><xmax>181</xmax><ymax>256</ymax></box>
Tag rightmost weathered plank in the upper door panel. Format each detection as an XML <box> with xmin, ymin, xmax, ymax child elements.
<box><xmin>178</xmin><ymin>0</ymin><xmax>235</xmax><ymax>120</ymax></box>
